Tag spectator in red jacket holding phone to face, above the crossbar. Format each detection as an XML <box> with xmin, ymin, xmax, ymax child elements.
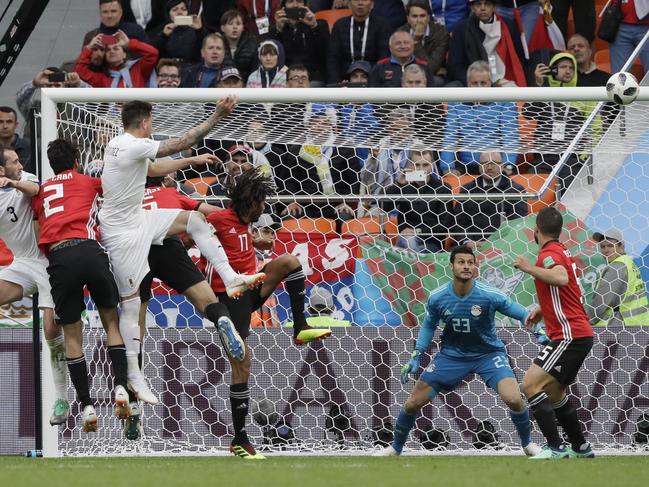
<box><xmin>75</xmin><ymin>30</ymin><xmax>158</xmax><ymax>88</ymax></box>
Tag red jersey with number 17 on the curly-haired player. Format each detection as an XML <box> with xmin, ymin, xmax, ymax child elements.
<box><xmin>198</xmin><ymin>208</ymin><xmax>257</xmax><ymax>293</ymax></box>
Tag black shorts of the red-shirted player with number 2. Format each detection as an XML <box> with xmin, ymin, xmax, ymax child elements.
<box><xmin>47</xmin><ymin>240</ymin><xmax>119</xmax><ymax>325</ymax></box>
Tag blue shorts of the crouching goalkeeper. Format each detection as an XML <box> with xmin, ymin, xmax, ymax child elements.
<box><xmin>419</xmin><ymin>352</ymin><xmax>516</xmax><ymax>392</ymax></box>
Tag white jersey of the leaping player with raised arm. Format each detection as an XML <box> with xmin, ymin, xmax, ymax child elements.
<box><xmin>99</xmin><ymin>133</ymin><xmax>160</xmax><ymax>232</ymax></box>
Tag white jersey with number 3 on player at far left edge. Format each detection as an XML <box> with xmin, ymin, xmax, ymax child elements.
<box><xmin>0</xmin><ymin>171</ymin><xmax>41</xmax><ymax>258</ymax></box>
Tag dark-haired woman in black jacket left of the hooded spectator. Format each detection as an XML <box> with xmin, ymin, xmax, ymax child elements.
<box><xmin>221</xmin><ymin>10</ymin><xmax>258</xmax><ymax>80</ymax></box>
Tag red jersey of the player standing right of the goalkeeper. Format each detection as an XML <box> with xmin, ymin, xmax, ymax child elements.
<box><xmin>534</xmin><ymin>240</ymin><xmax>593</xmax><ymax>340</ymax></box>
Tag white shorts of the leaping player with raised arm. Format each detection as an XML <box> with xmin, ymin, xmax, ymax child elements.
<box><xmin>99</xmin><ymin>209</ymin><xmax>183</xmax><ymax>297</ymax></box>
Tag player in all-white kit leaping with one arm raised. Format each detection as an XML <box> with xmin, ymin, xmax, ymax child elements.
<box><xmin>99</xmin><ymin>97</ymin><xmax>265</xmax><ymax>404</ymax></box>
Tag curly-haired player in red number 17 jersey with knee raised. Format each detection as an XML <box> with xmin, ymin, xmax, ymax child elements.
<box><xmin>200</xmin><ymin>169</ymin><xmax>331</xmax><ymax>459</ymax></box>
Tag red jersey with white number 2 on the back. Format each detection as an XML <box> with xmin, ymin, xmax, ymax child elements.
<box><xmin>32</xmin><ymin>170</ymin><xmax>102</xmax><ymax>253</ymax></box>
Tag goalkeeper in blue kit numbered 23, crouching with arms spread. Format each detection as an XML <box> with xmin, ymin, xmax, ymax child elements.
<box><xmin>376</xmin><ymin>246</ymin><xmax>548</xmax><ymax>456</ymax></box>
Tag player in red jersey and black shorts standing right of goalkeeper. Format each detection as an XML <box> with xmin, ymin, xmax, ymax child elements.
<box><xmin>514</xmin><ymin>207</ymin><xmax>595</xmax><ymax>460</ymax></box>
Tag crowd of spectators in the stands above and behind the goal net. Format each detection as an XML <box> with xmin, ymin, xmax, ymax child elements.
<box><xmin>11</xmin><ymin>0</ymin><xmax>649</xmax><ymax>252</ymax></box>
